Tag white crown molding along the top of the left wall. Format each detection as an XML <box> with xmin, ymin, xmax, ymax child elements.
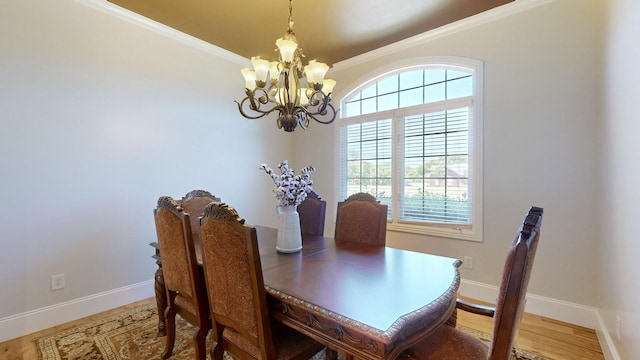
<box><xmin>75</xmin><ymin>0</ymin><xmax>248</xmax><ymax>66</ymax></box>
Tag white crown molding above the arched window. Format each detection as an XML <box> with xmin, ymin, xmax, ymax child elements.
<box><xmin>332</xmin><ymin>0</ymin><xmax>554</xmax><ymax>71</ymax></box>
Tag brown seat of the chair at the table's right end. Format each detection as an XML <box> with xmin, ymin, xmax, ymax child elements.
<box><xmin>404</xmin><ymin>325</ymin><xmax>489</xmax><ymax>360</ymax></box>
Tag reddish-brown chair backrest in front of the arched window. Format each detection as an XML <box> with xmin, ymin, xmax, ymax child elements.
<box><xmin>335</xmin><ymin>193</ymin><xmax>387</xmax><ymax>246</ymax></box>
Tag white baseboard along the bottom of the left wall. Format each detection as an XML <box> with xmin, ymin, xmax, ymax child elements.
<box><xmin>0</xmin><ymin>280</ymin><xmax>155</xmax><ymax>342</ymax></box>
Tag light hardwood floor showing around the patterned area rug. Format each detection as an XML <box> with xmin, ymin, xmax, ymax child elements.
<box><xmin>0</xmin><ymin>299</ymin><xmax>604</xmax><ymax>360</ymax></box>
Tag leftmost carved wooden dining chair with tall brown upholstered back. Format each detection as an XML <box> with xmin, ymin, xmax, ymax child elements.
<box><xmin>154</xmin><ymin>196</ymin><xmax>211</xmax><ymax>360</ymax></box>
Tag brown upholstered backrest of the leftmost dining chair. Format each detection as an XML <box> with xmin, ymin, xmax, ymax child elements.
<box><xmin>154</xmin><ymin>196</ymin><xmax>207</xmax><ymax>315</ymax></box>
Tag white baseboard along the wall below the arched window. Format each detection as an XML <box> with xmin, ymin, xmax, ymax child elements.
<box><xmin>460</xmin><ymin>279</ymin><xmax>600</xmax><ymax>330</ymax></box>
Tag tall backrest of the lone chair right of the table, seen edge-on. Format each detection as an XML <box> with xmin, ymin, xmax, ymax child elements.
<box><xmin>489</xmin><ymin>207</ymin><xmax>543</xmax><ymax>360</ymax></box>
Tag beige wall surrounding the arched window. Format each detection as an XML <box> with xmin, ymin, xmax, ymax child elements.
<box><xmin>296</xmin><ymin>0</ymin><xmax>602</xmax><ymax>306</ymax></box>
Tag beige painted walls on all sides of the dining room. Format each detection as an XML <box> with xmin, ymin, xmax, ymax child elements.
<box><xmin>0</xmin><ymin>0</ymin><xmax>640</xmax><ymax>358</ymax></box>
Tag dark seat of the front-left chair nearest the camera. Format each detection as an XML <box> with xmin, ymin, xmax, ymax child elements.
<box><xmin>222</xmin><ymin>321</ymin><xmax>324</xmax><ymax>360</ymax></box>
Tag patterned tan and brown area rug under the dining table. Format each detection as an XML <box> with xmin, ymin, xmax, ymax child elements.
<box><xmin>36</xmin><ymin>303</ymin><xmax>550</xmax><ymax>360</ymax></box>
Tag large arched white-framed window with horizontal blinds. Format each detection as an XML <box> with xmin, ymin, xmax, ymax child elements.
<box><xmin>338</xmin><ymin>57</ymin><xmax>482</xmax><ymax>241</ymax></box>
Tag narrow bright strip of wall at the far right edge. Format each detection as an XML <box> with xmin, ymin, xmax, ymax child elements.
<box><xmin>598</xmin><ymin>0</ymin><xmax>640</xmax><ymax>359</ymax></box>
